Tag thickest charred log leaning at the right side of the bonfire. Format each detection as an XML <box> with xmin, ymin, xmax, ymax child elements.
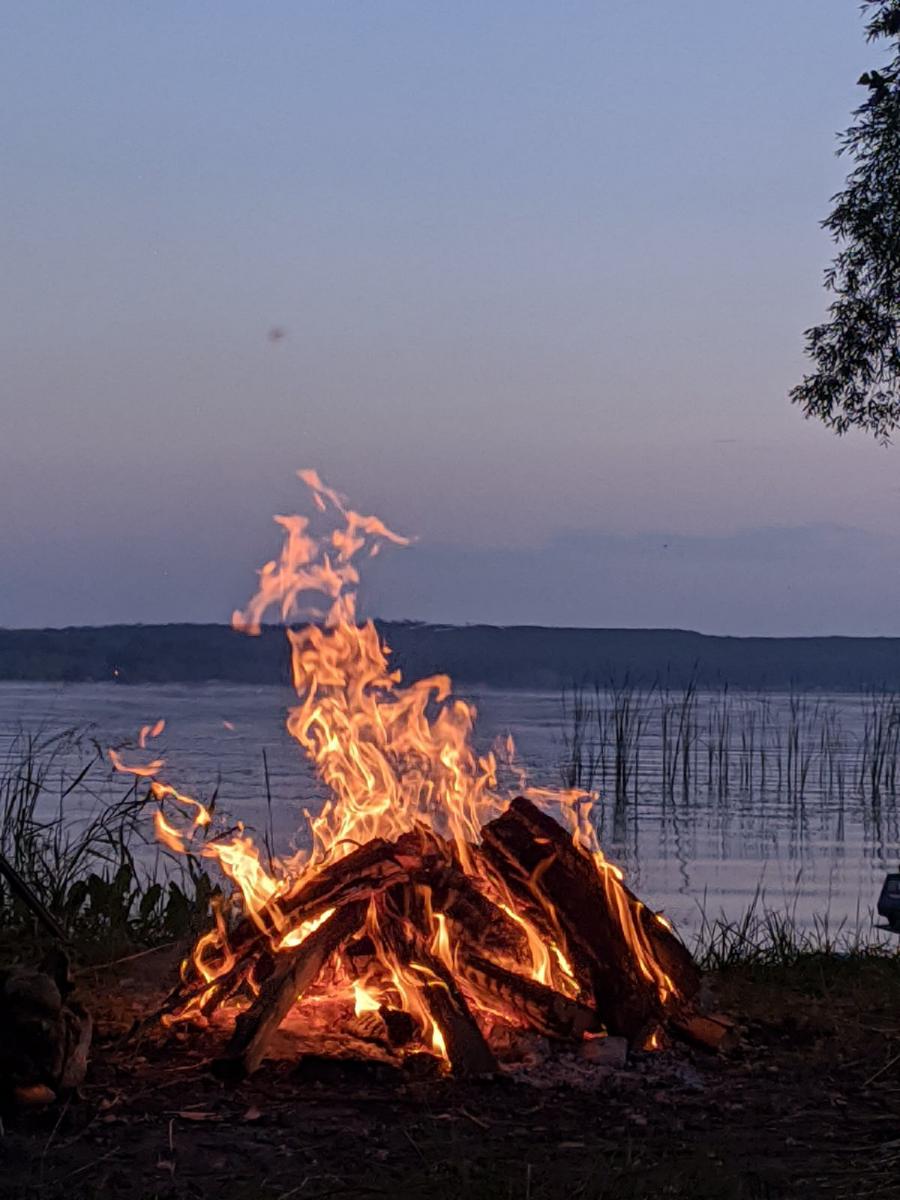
<box><xmin>482</xmin><ymin>797</ymin><xmax>698</xmax><ymax>1039</ymax></box>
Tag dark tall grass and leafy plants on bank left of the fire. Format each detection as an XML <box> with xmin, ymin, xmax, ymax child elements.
<box><xmin>0</xmin><ymin>731</ymin><xmax>215</xmax><ymax>961</ymax></box>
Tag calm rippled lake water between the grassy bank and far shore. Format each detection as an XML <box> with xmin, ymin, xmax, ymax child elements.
<box><xmin>0</xmin><ymin>683</ymin><xmax>900</xmax><ymax>934</ymax></box>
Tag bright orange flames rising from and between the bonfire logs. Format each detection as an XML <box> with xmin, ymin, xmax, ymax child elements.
<box><xmin>110</xmin><ymin>470</ymin><xmax>672</xmax><ymax>1054</ymax></box>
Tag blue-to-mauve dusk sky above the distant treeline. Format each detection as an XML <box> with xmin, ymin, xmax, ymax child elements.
<box><xmin>0</xmin><ymin>0</ymin><xmax>900</xmax><ymax>635</ymax></box>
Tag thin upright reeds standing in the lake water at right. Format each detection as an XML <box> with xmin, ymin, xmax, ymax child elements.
<box><xmin>560</xmin><ymin>683</ymin><xmax>900</xmax><ymax>820</ymax></box>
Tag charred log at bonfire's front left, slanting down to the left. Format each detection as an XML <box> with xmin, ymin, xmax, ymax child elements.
<box><xmin>216</xmin><ymin>901</ymin><xmax>367</xmax><ymax>1080</ymax></box>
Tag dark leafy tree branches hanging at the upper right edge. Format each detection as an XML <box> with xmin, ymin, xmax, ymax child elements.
<box><xmin>791</xmin><ymin>0</ymin><xmax>900</xmax><ymax>440</ymax></box>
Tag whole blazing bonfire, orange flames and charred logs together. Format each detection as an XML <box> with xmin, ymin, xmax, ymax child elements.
<box><xmin>110</xmin><ymin>470</ymin><xmax>698</xmax><ymax>1078</ymax></box>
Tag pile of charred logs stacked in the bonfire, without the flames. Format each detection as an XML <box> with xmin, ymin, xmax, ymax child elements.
<box><xmin>157</xmin><ymin>797</ymin><xmax>700</xmax><ymax>1079</ymax></box>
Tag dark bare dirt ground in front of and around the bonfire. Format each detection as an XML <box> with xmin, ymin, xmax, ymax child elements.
<box><xmin>0</xmin><ymin>954</ymin><xmax>900</xmax><ymax>1200</ymax></box>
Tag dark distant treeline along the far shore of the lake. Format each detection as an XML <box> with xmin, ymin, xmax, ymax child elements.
<box><xmin>0</xmin><ymin>622</ymin><xmax>900</xmax><ymax>690</ymax></box>
